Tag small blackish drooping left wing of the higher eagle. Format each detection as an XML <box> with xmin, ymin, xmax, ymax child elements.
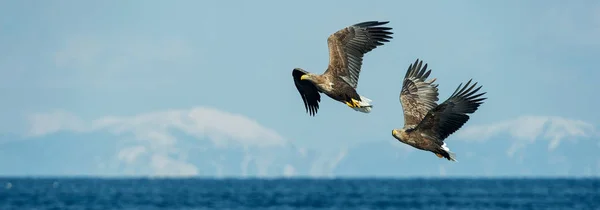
<box><xmin>292</xmin><ymin>69</ymin><xmax>321</xmax><ymax>116</ymax></box>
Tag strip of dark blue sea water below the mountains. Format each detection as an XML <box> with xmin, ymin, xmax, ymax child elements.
<box><xmin>0</xmin><ymin>178</ymin><xmax>600</xmax><ymax>210</ymax></box>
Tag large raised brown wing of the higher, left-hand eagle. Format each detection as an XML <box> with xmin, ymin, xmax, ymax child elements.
<box><xmin>323</xmin><ymin>21</ymin><xmax>393</xmax><ymax>88</ymax></box>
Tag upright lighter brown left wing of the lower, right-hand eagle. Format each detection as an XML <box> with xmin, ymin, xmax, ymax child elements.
<box><xmin>400</xmin><ymin>59</ymin><xmax>438</xmax><ymax>128</ymax></box>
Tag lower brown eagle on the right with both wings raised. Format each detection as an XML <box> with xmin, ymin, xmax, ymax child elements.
<box><xmin>392</xmin><ymin>59</ymin><xmax>487</xmax><ymax>161</ymax></box>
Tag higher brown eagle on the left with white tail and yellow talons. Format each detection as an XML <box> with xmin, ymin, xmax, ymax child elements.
<box><xmin>292</xmin><ymin>21</ymin><xmax>393</xmax><ymax>116</ymax></box>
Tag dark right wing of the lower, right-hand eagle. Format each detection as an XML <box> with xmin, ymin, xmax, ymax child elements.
<box><xmin>415</xmin><ymin>80</ymin><xmax>486</xmax><ymax>141</ymax></box>
